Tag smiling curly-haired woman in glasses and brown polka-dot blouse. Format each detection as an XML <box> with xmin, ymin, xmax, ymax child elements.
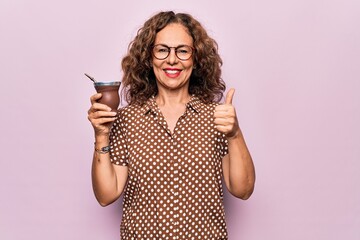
<box><xmin>88</xmin><ymin>12</ymin><xmax>255</xmax><ymax>239</ymax></box>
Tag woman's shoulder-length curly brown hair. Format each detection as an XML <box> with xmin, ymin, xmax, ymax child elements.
<box><xmin>121</xmin><ymin>11</ymin><xmax>225</xmax><ymax>105</ymax></box>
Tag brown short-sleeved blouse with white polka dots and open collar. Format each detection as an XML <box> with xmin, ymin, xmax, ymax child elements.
<box><xmin>110</xmin><ymin>96</ymin><xmax>228</xmax><ymax>240</ymax></box>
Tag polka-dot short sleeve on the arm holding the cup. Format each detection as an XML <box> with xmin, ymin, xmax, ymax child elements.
<box><xmin>110</xmin><ymin>111</ymin><xmax>128</xmax><ymax>166</ymax></box>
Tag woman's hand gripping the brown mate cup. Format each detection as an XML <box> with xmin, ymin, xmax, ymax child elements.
<box><xmin>88</xmin><ymin>93</ymin><xmax>116</xmax><ymax>137</ymax></box>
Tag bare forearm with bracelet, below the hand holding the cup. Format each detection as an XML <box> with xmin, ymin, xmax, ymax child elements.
<box><xmin>92</xmin><ymin>137</ymin><xmax>119</xmax><ymax>206</ymax></box>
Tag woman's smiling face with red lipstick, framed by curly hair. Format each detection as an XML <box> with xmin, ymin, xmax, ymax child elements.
<box><xmin>152</xmin><ymin>23</ymin><xmax>194</xmax><ymax>93</ymax></box>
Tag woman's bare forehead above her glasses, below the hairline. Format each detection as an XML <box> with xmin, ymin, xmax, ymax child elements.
<box><xmin>155</xmin><ymin>23</ymin><xmax>193</xmax><ymax>47</ymax></box>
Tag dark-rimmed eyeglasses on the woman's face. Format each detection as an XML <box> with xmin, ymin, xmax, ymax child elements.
<box><xmin>153</xmin><ymin>44</ymin><xmax>194</xmax><ymax>61</ymax></box>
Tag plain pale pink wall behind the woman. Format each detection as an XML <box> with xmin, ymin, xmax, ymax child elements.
<box><xmin>0</xmin><ymin>0</ymin><xmax>360</xmax><ymax>240</ymax></box>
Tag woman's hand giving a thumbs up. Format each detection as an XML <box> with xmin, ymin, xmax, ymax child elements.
<box><xmin>214</xmin><ymin>88</ymin><xmax>240</xmax><ymax>139</ymax></box>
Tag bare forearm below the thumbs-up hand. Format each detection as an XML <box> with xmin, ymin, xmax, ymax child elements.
<box><xmin>227</xmin><ymin>129</ymin><xmax>255</xmax><ymax>199</ymax></box>
